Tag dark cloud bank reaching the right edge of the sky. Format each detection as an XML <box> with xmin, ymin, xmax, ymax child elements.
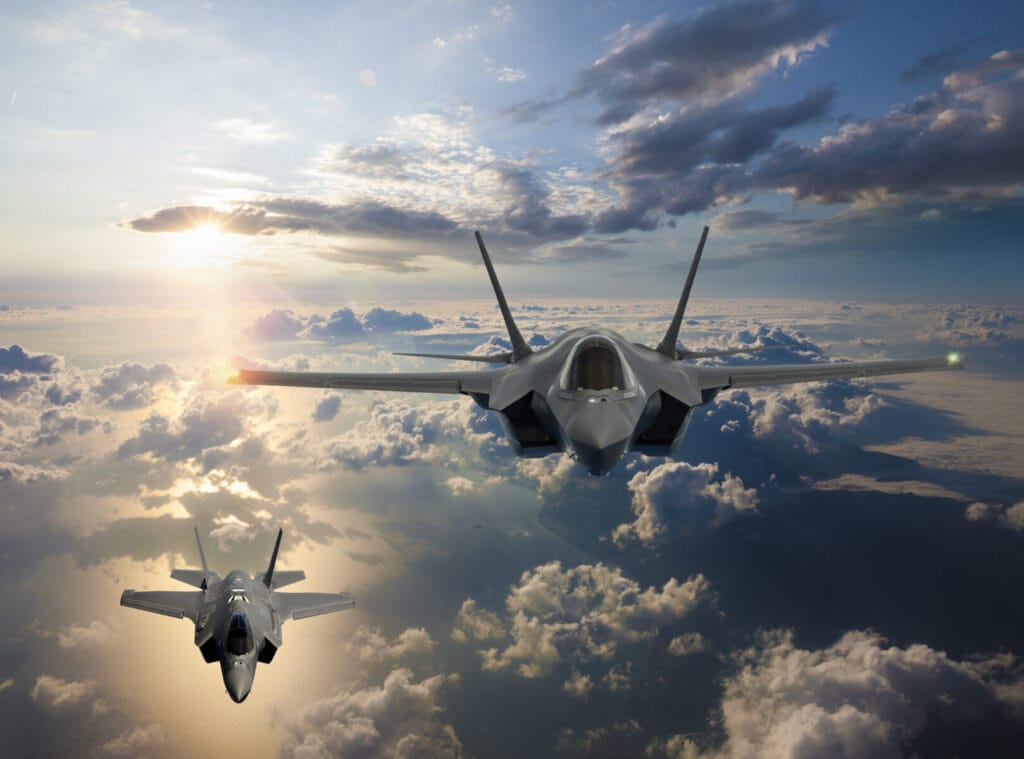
<box><xmin>750</xmin><ymin>50</ymin><xmax>1024</xmax><ymax>203</ymax></box>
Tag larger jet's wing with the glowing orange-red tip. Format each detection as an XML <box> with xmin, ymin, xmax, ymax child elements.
<box><xmin>227</xmin><ymin>369</ymin><xmax>497</xmax><ymax>394</ymax></box>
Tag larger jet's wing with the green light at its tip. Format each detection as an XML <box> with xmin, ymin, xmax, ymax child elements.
<box><xmin>696</xmin><ymin>354</ymin><xmax>963</xmax><ymax>390</ymax></box>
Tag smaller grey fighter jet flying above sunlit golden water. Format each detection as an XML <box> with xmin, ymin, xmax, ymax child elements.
<box><xmin>121</xmin><ymin>528</ymin><xmax>355</xmax><ymax>704</ymax></box>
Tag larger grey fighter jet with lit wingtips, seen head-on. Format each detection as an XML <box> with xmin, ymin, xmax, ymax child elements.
<box><xmin>228</xmin><ymin>226</ymin><xmax>961</xmax><ymax>474</ymax></box>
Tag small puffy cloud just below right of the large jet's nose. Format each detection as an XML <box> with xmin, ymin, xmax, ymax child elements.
<box><xmin>612</xmin><ymin>461</ymin><xmax>758</xmax><ymax>543</ymax></box>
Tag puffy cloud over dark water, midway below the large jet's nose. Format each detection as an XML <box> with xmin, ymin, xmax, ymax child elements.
<box><xmin>468</xmin><ymin>561</ymin><xmax>711</xmax><ymax>678</ymax></box>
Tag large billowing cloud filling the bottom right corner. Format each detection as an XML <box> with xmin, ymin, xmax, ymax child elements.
<box><xmin>682</xmin><ymin>630</ymin><xmax>1022</xmax><ymax>759</ymax></box>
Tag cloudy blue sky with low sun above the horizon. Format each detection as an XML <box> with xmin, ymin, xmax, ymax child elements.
<box><xmin>0</xmin><ymin>1</ymin><xmax>1024</xmax><ymax>302</ymax></box>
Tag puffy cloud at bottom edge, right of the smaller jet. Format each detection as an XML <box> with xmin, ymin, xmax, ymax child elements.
<box><xmin>281</xmin><ymin>668</ymin><xmax>463</xmax><ymax>759</ymax></box>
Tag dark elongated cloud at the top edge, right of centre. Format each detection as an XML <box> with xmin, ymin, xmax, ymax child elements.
<box><xmin>512</xmin><ymin>0</ymin><xmax>837</xmax><ymax>125</ymax></box>
